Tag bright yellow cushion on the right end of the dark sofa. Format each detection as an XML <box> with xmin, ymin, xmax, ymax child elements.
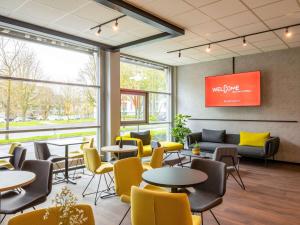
<box><xmin>239</xmin><ymin>131</ymin><xmax>270</xmax><ymax>147</ymax></box>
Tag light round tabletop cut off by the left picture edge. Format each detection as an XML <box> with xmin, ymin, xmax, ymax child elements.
<box><xmin>0</xmin><ymin>170</ymin><xmax>35</xmax><ymax>192</ymax></box>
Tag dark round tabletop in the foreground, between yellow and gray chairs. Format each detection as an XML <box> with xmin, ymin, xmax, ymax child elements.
<box><xmin>142</xmin><ymin>167</ymin><xmax>208</xmax><ymax>193</ymax></box>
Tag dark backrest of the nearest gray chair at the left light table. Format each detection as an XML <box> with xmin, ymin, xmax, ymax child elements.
<box><xmin>21</xmin><ymin>160</ymin><xmax>53</xmax><ymax>196</ymax></box>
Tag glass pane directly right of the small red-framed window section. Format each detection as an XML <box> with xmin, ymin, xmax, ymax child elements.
<box><xmin>149</xmin><ymin>93</ymin><xmax>171</xmax><ymax>123</ymax></box>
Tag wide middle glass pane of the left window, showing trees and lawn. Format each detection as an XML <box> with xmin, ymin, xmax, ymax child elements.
<box><xmin>0</xmin><ymin>79</ymin><xmax>100</xmax><ymax>134</ymax></box>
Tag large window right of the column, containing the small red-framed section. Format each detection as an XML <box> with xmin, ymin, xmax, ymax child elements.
<box><xmin>120</xmin><ymin>57</ymin><xmax>172</xmax><ymax>140</ymax></box>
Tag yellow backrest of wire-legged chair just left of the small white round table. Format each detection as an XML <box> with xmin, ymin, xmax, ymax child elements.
<box><xmin>83</xmin><ymin>148</ymin><xmax>101</xmax><ymax>173</ymax></box>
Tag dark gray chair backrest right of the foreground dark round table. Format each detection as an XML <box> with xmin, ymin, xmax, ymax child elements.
<box><xmin>191</xmin><ymin>159</ymin><xmax>226</xmax><ymax>197</ymax></box>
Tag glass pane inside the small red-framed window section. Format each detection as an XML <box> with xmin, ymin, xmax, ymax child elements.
<box><xmin>121</xmin><ymin>94</ymin><xmax>146</xmax><ymax>121</ymax></box>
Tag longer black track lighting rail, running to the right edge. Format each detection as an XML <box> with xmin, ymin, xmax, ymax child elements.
<box><xmin>167</xmin><ymin>23</ymin><xmax>300</xmax><ymax>56</ymax></box>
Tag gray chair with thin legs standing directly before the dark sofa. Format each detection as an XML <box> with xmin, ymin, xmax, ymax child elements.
<box><xmin>213</xmin><ymin>147</ymin><xmax>246</xmax><ymax>190</ymax></box>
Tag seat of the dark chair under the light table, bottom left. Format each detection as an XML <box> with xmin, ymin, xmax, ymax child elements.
<box><xmin>0</xmin><ymin>191</ymin><xmax>47</xmax><ymax>214</ymax></box>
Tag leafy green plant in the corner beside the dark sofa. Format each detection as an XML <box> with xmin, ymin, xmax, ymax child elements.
<box><xmin>171</xmin><ymin>114</ymin><xmax>192</xmax><ymax>144</ymax></box>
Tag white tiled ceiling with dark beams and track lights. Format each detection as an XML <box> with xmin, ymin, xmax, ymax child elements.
<box><xmin>0</xmin><ymin>0</ymin><xmax>300</xmax><ymax>65</ymax></box>
